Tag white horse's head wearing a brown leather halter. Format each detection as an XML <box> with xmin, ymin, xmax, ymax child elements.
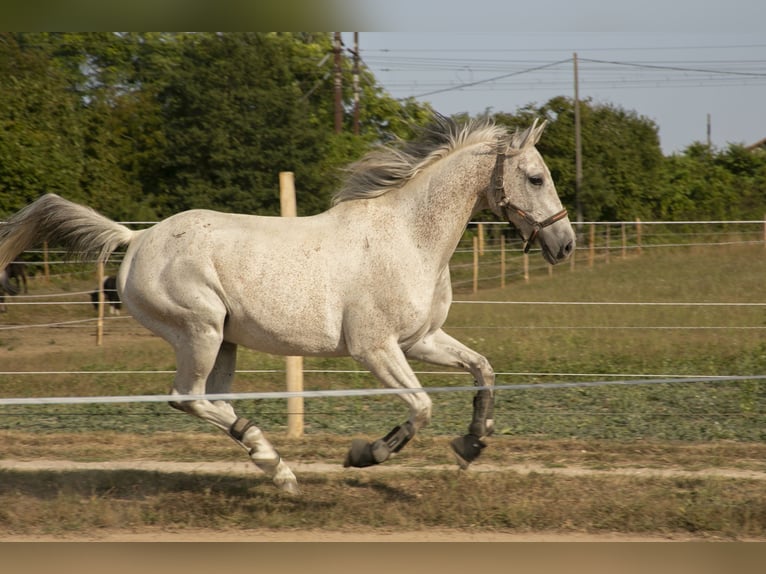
<box><xmin>487</xmin><ymin>120</ymin><xmax>575</xmax><ymax>265</ymax></box>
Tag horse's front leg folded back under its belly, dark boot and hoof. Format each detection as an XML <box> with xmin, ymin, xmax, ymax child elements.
<box><xmin>343</xmin><ymin>341</ymin><xmax>431</xmax><ymax>467</ymax></box>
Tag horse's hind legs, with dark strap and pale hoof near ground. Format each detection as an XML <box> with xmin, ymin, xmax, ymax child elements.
<box><xmin>171</xmin><ymin>339</ymin><xmax>299</xmax><ymax>494</ymax></box>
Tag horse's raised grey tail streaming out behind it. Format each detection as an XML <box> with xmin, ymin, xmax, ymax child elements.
<box><xmin>0</xmin><ymin>193</ymin><xmax>139</xmax><ymax>269</ymax></box>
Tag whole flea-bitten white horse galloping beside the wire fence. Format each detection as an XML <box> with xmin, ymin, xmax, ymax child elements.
<box><xmin>0</xmin><ymin>116</ymin><xmax>575</xmax><ymax>492</ymax></box>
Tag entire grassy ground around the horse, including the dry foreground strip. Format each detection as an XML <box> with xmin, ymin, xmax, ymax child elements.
<box><xmin>0</xmin><ymin>246</ymin><xmax>766</xmax><ymax>538</ymax></box>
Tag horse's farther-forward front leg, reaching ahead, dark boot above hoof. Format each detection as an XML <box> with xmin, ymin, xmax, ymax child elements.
<box><xmin>407</xmin><ymin>330</ymin><xmax>495</xmax><ymax>469</ymax></box>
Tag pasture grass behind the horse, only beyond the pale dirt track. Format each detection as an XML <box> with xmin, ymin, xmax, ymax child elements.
<box><xmin>0</xmin><ymin>246</ymin><xmax>766</xmax><ymax>441</ymax></box>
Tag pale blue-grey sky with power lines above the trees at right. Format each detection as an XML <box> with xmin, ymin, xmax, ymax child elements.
<box><xmin>343</xmin><ymin>0</ymin><xmax>766</xmax><ymax>153</ymax></box>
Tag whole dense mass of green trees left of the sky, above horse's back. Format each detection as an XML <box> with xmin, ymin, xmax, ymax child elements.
<box><xmin>0</xmin><ymin>33</ymin><xmax>436</xmax><ymax>220</ymax></box>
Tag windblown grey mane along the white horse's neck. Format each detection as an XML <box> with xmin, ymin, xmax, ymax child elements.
<box><xmin>333</xmin><ymin>114</ymin><xmax>512</xmax><ymax>205</ymax></box>
